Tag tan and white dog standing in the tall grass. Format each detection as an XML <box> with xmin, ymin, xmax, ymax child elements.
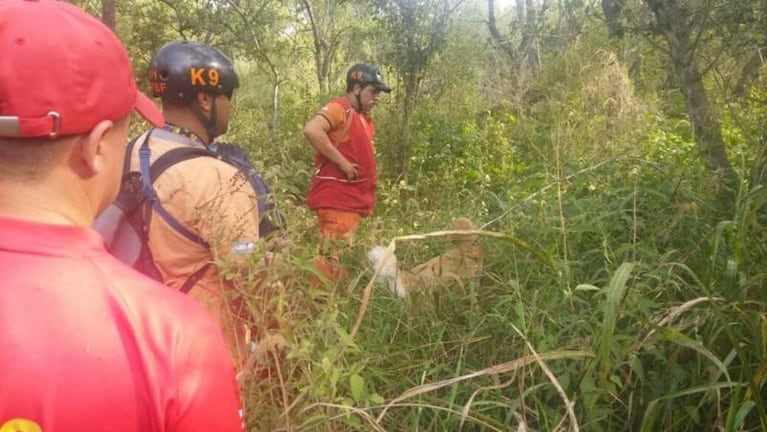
<box><xmin>367</xmin><ymin>218</ymin><xmax>482</xmax><ymax>298</ymax></box>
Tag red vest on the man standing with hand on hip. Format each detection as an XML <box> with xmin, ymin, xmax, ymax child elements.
<box><xmin>307</xmin><ymin>98</ymin><xmax>377</xmax><ymax>216</ymax></box>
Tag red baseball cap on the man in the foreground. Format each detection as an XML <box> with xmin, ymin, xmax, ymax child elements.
<box><xmin>0</xmin><ymin>0</ymin><xmax>164</xmax><ymax>138</ymax></box>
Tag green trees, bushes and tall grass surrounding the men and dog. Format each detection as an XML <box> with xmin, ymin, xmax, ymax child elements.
<box><xmin>81</xmin><ymin>0</ymin><xmax>767</xmax><ymax>431</ymax></box>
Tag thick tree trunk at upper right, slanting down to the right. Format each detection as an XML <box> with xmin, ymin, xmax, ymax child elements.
<box><xmin>645</xmin><ymin>0</ymin><xmax>735</xmax><ymax>191</ymax></box>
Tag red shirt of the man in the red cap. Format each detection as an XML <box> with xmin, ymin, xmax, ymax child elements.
<box><xmin>0</xmin><ymin>218</ymin><xmax>243</xmax><ymax>432</ymax></box>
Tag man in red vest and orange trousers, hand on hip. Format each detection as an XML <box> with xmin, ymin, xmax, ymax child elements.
<box><xmin>304</xmin><ymin>63</ymin><xmax>391</xmax><ymax>280</ymax></box>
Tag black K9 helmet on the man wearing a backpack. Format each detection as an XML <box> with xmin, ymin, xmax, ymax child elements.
<box><xmin>149</xmin><ymin>41</ymin><xmax>240</xmax><ymax>103</ymax></box>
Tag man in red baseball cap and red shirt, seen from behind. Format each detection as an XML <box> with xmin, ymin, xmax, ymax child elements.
<box><xmin>0</xmin><ymin>0</ymin><xmax>243</xmax><ymax>432</ymax></box>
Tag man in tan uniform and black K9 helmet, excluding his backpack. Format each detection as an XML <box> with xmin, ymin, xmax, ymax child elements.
<box><xmin>131</xmin><ymin>41</ymin><xmax>259</xmax><ymax>370</ymax></box>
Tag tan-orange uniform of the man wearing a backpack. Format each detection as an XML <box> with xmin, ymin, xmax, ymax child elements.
<box><xmin>131</xmin><ymin>129</ymin><xmax>259</xmax><ymax>366</ymax></box>
